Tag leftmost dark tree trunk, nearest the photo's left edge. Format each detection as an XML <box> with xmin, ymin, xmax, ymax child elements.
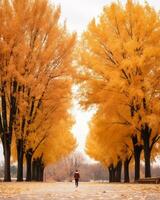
<box><xmin>4</xmin><ymin>135</ymin><xmax>11</xmax><ymax>182</ymax></box>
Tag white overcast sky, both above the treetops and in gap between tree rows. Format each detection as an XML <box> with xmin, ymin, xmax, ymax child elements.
<box><xmin>51</xmin><ymin>0</ymin><xmax>160</xmax><ymax>156</ymax></box>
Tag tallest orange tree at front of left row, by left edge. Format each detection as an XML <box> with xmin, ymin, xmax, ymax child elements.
<box><xmin>0</xmin><ymin>0</ymin><xmax>75</xmax><ymax>181</ymax></box>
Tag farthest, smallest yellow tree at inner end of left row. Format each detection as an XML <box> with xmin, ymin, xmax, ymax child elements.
<box><xmin>32</xmin><ymin>116</ymin><xmax>76</xmax><ymax>181</ymax></box>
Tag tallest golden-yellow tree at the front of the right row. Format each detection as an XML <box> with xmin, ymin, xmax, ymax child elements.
<box><xmin>78</xmin><ymin>0</ymin><xmax>160</xmax><ymax>179</ymax></box>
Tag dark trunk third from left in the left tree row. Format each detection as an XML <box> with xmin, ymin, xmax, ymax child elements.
<box><xmin>26</xmin><ymin>149</ymin><xmax>33</xmax><ymax>181</ymax></box>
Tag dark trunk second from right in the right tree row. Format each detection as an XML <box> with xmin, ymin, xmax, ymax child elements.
<box><xmin>132</xmin><ymin>135</ymin><xmax>143</xmax><ymax>181</ymax></box>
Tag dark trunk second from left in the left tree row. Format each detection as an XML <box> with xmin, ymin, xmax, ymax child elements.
<box><xmin>17</xmin><ymin>139</ymin><xmax>24</xmax><ymax>181</ymax></box>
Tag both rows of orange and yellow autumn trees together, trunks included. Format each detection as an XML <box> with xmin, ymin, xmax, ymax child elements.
<box><xmin>0</xmin><ymin>0</ymin><xmax>160</xmax><ymax>182</ymax></box>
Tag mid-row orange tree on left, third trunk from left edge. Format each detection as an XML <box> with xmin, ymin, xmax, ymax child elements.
<box><xmin>23</xmin><ymin>90</ymin><xmax>75</xmax><ymax>181</ymax></box>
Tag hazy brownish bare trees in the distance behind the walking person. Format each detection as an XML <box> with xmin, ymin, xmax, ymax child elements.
<box><xmin>45</xmin><ymin>152</ymin><xmax>108</xmax><ymax>181</ymax></box>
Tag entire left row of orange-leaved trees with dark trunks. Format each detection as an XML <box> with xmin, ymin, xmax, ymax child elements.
<box><xmin>0</xmin><ymin>0</ymin><xmax>76</xmax><ymax>181</ymax></box>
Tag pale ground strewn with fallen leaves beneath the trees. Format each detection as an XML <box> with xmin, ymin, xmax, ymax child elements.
<box><xmin>0</xmin><ymin>183</ymin><xmax>160</xmax><ymax>200</ymax></box>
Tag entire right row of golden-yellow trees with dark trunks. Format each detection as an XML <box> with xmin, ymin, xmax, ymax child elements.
<box><xmin>77</xmin><ymin>0</ymin><xmax>160</xmax><ymax>182</ymax></box>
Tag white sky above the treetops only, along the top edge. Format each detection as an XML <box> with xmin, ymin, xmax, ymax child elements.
<box><xmin>51</xmin><ymin>0</ymin><xmax>160</xmax><ymax>32</ymax></box>
